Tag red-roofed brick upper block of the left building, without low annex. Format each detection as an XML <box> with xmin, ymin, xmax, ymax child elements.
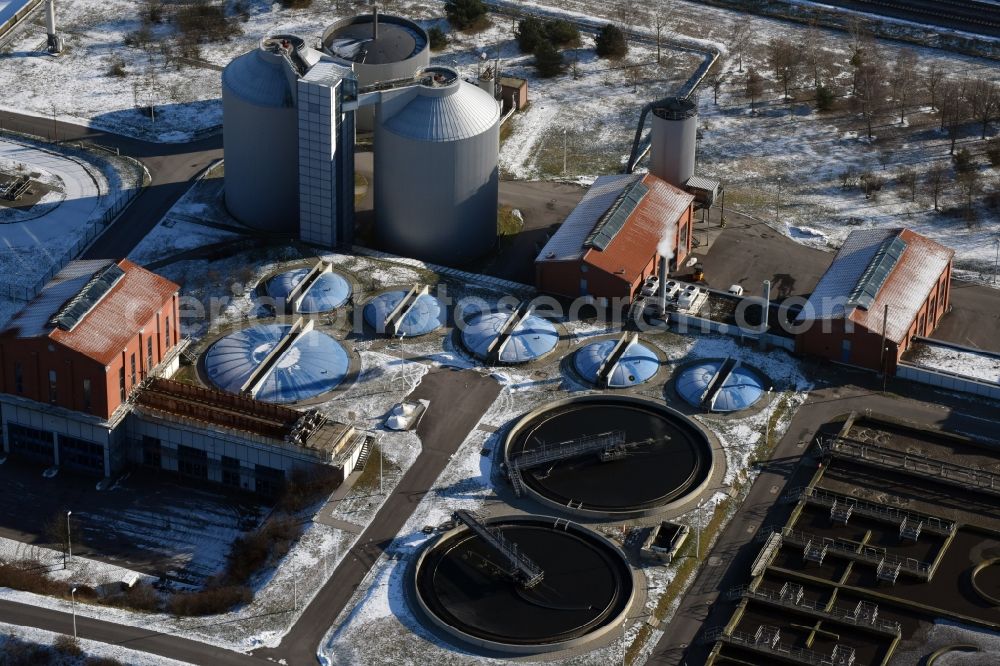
<box><xmin>0</xmin><ymin>260</ymin><xmax>180</xmax><ymax>419</ymax></box>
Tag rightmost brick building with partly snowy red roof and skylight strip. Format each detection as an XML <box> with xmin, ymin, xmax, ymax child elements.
<box><xmin>795</xmin><ymin>229</ymin><xmax>955</xmax><ymax>374</ymax></box>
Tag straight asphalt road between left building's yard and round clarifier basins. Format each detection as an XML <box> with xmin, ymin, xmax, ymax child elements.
<box><xmin>255</xmin><ymin>369</ymin><xmax>500</xmax><ymax>665</ymax></box>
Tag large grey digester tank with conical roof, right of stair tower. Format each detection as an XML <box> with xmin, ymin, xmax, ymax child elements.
<box><xmin>375</xmin><ymin>67</ymin><xmax>500</xmax><ymax>265</ymax></box>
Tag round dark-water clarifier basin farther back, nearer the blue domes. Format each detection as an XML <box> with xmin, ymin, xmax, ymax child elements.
<box><xmin>504</xmin><ymin>395</ymin><xmax>714</xmax><ymax>519</ymax></box>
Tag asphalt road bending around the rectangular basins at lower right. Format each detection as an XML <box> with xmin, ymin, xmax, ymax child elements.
<box><xmin>647</xmin><ymin>364</ymin><xmax>996</xmax><ymax>665</ymax></box>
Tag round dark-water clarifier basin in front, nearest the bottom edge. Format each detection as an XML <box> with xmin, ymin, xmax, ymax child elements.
<box><xmin>414</xmin><ymin>516</ymin><xmax>635</xmax><ymax>654</ymax></box>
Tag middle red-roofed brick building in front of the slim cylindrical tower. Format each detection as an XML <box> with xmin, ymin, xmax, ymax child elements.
<box><xmin>535</xmin><ymin>174</ymin><xmax>694</xmax><ymax>300</ymax></box>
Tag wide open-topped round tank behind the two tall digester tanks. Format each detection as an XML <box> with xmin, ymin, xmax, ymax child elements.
<box><xmin>323</xmin><ymin>13</ymin><xmax>431</xmax><ymax>132</ymax></box>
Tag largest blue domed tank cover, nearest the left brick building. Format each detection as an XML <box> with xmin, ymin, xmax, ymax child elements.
<box><xmin>205</xmin><ymin>324</ymin><xmax>350</xmax><ymax>403</ymax></box>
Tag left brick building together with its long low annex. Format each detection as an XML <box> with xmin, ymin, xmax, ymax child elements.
<box><xmin>0</xmin><ymin>260</ymin><xmax>368</xmax><ymax>488</ymax></box>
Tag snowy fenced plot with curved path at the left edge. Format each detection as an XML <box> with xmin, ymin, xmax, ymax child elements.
<box><xmin>0</xmin><ymin>138</ymin><xmax>137</xmax><ymax>296</ymax></box>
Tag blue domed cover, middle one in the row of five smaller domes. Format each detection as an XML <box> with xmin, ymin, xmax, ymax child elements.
<box><xmin>462</xmin><ymin>312</ymin><xmax>559</xmax><ymax>363</ymax></box>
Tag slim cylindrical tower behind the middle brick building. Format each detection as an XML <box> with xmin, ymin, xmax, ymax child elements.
<box><xmin>649</xmin><ymin>97</ymin><xmax>698</xmax><ymax>187</ymax></box>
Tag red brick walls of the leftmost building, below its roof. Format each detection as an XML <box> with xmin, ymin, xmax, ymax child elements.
<box><xmin>0</xmin><ymin>296</ymin><xmax>180</xmax><ymax>418</ymax></box>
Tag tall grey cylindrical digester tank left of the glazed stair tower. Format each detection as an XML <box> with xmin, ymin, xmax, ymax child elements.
<box><xmin>222</xmin><ymin>35</ymin><xmax>302</xmax><ymax>234</ymax></box>
